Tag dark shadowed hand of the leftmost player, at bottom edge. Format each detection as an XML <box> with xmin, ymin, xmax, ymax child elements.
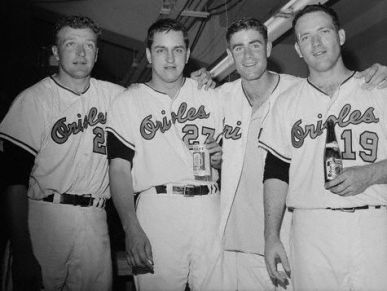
<box><xmin>12</xmin><ymin>252</ymin><xmax>43</xmax><ymax>291</ymax></box>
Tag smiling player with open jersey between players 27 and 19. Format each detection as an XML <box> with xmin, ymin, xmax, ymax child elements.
<box><xmin>193</xmin><ymin>18</ymin><xmax>386</xmax><ymax>290</ymax></box>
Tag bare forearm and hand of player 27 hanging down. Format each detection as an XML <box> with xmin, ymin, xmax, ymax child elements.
<box><xmin>109</xmin><ymin>158</ymin><xmax>153</xmax><ymax>272</ymax></box>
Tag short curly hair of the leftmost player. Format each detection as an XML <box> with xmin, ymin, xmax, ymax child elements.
<box><xmin>53</xmin><ymin>15</ymin><xmax>102</xmax><ymax>44</ymax></box>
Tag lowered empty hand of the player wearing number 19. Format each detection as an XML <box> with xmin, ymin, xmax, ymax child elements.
<box><xmin>265</xmin><ymin>239</ymin><xmax>290</xmax><ymax>288</ymax></box>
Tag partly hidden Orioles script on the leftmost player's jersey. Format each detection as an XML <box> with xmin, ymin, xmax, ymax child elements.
<box><xmin>51</xmin><ymin>107</ymin><xmax>106</xmax><ymax>144</ymax></box>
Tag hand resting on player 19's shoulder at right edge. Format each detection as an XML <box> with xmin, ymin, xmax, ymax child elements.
<box><xmin>355</xmin><ymin>63</ymin><xmax>387</xmax><ymax>89</ymax></box>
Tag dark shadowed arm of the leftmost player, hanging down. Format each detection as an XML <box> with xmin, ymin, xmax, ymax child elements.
<box><xmin>1</xmin><ymin>140</ymin><xmax>42</xmax><ymax>290</ymax></box>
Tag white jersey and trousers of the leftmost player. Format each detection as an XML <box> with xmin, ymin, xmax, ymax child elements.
<box><xmin>0</xmin><ymin>77</ymin><xmax>123</xmax><ymax>290</ymax></box>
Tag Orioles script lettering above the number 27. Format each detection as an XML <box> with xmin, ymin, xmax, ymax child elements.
<box><xmin>140</xmin><ymin>102</ymin><xmax>210</xmax><ymax>140</ymax></box>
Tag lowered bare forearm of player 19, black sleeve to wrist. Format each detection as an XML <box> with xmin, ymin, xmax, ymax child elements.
<box><xmin>264</xmin><ymin>179</ymin><xmax>288</xmax><ymax>240</ymax></box>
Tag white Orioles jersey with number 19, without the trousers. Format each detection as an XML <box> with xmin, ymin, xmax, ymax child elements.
<box><xmin>260</xmin><ymin>73</ymin><xmax>387</xmax><ymax>209</ymax></box>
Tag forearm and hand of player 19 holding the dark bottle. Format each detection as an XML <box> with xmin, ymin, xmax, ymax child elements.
<box><xmin>325</xmin><ymin>160</ymin><xmax>387</xmax><ymax>196</ymax></box>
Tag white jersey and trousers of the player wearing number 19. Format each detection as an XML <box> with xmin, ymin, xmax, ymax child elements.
<box><xmin>260</xmin><ymin>76</ymin><xmax>387</xmax><ymax>290</ymax></box>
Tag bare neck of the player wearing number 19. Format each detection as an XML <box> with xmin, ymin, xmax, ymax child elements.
<box><xmin>308</xmin><ymin>59</ymin><xmax>353</xmax><ymax>97</ymax></box>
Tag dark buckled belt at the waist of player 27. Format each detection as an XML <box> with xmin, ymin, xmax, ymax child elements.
<box><xmin>141</xmin><ymin>183</ymin><xmax>219</xmax><ymax>197</ymax></box>
